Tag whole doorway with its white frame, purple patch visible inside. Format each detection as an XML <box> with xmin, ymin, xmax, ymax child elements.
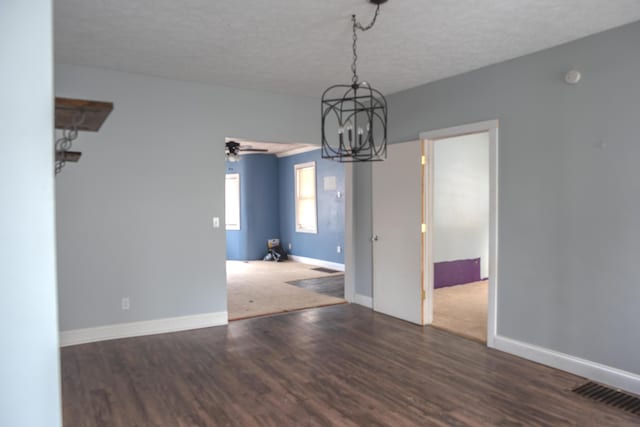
<box><xmin>420</xmin><ymin>121</ymin><xmax>498</xmax><ymax>346</ymax></box>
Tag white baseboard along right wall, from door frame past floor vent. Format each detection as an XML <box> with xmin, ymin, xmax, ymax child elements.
<box><xmin>493</xmin><ymin>335</ymin><xmax>640</xmax><ymax>394</ymax></box>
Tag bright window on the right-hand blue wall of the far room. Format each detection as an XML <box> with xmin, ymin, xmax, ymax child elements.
<box><xmin>295</xmin><ymin>162</ymin><xmax>318</xmax><ymax>233</ymax></box>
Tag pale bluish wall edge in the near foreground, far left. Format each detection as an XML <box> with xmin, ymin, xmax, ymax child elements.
<box><xmin>0</xmin><ymin>0</ymin><xmax>61</xmax><ymax>427</ymax></box>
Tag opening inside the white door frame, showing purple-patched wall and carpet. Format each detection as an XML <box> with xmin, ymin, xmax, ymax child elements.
<box><xmin>431</xmin><ymin>132</ymin><xmax>489</xmax><ymax>342</ymax></box>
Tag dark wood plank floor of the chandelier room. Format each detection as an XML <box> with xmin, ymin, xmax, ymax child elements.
<box><xmin>62</xmin><ymin>305</ymin><xmax>640</xmax><ymax>427</ymax></box>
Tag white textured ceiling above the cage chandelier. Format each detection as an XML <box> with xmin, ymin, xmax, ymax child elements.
<box><xmin>54</xmin><ymin>0</ymin><xmax>640</xmax><ymax>97</ymax></box>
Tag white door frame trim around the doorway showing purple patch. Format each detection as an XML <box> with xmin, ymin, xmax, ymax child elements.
<box><xmin>420</xmin><ymin>120</ymin><xmax>499</xmax><ymax>347</ymax></box>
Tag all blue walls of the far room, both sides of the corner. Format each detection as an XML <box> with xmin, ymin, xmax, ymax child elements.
<box><xmin>226</xmin><ymin>150</ymin><xmax>344</xmax><ymax>264</ymax></box>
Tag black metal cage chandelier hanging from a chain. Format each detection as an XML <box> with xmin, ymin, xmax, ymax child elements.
<box><xmin>322</xmin><ymin>0</ymin><xmax>387</xmax><ymax>162</ymax></box>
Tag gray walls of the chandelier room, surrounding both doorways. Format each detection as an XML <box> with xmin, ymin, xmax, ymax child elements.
<box><xmin>56</xmin><ymin>23</ymin><xmax>640</xmax><ymax>373</ymax></box>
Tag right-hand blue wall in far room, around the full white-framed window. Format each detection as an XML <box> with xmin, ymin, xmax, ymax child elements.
<box><xmin>278</xmin><ymin>150</ymin><xmax>344</xmax><ymax>264</ymax></box>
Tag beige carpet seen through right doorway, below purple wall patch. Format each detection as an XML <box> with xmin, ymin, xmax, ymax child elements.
<box><xmin>433</xmin><ymin>280</ymin><xmax>489</xmax><ymax>342</ymax></box>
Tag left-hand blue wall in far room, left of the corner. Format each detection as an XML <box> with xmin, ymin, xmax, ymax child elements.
<box><xmin>226</xmin><ymin>154</ymin><xmax>280</xmax><ymax>260</ymax></box>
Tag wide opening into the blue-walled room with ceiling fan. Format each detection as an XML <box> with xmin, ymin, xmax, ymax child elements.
<box><xmin>225</xmin><ymin>138</ymin><xmax>346</xmax><ymax>321</ymax></box>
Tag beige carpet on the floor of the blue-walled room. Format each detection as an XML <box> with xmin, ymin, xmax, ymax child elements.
<box><xmin>227</xmin><ymin>261</ymin><xmax>346</xmax><ymax>320</ymax></box>
